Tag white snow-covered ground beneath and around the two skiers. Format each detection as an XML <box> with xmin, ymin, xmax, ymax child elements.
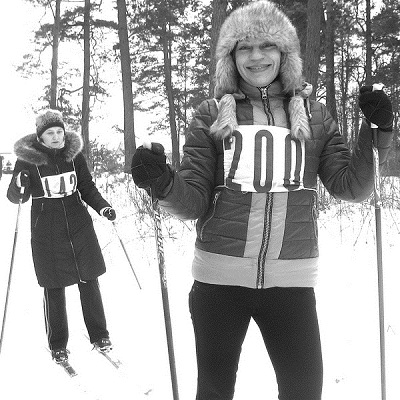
<box><xmin>0</xmin><ymin>175</ymin><xmax>400</xmax><ymax>400</ymax></box>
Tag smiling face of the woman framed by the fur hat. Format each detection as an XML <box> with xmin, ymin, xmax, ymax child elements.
<box><xmin>235</xmin><ymin>38</ymin><xmax>281</xmax><ymax>87</ymax></box>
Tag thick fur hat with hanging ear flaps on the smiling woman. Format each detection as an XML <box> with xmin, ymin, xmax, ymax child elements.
<box><xmin>211</xmin><ymin>0</ymin><xmax>310</xmax><ymax>139</ymax></box>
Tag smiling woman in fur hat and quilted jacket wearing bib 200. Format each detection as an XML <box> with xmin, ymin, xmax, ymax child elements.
<box><xmin>132</xmin><ymin>1</ymin><xmax>393</xmax><ymax>400</ymax></box>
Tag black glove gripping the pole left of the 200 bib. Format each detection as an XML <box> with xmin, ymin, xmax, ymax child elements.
<box><xmin>131</xmin><ymin>143</ymin><xmax>172</xmax><ymax>198</ymax></box>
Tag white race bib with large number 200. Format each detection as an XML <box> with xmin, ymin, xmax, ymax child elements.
<box><xmin>224</xmin><ymin>125</ymin><xmax>305</xmax><ymax>193</ymax></box>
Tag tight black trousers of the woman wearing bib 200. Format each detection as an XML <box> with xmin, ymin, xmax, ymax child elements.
<box><xmin>189</xmin><ymin>282</ymin><xmax>322</xmax><ymax>400</ymax></box>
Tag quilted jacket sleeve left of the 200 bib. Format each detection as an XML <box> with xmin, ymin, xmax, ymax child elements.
<box><xmin>160</xmin><ymin>100</ymin><xmax>217</xmax><ymax>220</ymax></box>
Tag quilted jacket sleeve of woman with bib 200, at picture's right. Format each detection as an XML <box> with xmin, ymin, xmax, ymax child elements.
<box><xmin>318</xmin><ymin>106</ymin><xmax>393</xmax><ymax>202</ymax></box>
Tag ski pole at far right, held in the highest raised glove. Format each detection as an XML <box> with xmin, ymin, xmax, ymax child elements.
<box><xmin>371</xmin><ymin>83</ymin><xmax>386</xmax><ymax>400</ymax></box>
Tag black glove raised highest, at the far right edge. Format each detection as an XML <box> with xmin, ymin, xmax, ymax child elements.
<box><xmin>358</xmin><ymin>86</ymin><xmax>393</xmax><ymax>131</ymax></box>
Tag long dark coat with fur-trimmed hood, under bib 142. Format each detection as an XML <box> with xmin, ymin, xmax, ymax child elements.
<box><xmin>7</xmin><ymin>133</ymin><xmax>110</xmax><ymax>288</ymax></box>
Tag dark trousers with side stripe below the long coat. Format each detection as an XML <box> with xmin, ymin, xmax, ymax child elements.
<box><xmin>44</xmin><ymin>279</ymin><xmax>109</xmax><ymax>350</ymax></box>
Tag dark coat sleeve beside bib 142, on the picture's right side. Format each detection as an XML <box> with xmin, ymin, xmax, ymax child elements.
<box><xmin>75</xmin><ymin>153</ymin><xmax>111</xmax><ymax>213</ymax></box>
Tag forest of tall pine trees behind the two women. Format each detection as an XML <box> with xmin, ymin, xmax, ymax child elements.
<box><xmin>0</xmin><ymin>0</ymin><xmax>400</xmax><ymax>206</ymax></box>
